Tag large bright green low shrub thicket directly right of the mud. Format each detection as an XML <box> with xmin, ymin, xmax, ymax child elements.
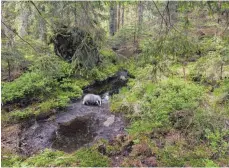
<box><xmin>111</xmin><ymin>76</ymin><xmax>204</xmax><ymax>134</ymax></box>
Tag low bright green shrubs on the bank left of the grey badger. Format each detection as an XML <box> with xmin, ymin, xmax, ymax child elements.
<box><xmin>3</xmin><ymin>73</ymin><xmax>88</xmax><ymax>122</ymax></box>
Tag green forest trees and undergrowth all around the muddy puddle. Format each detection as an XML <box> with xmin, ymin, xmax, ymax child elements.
<box><xmin>1</xmin><ymin>0</ymin><xmax>229</xmax><ymax>167</ymax></box>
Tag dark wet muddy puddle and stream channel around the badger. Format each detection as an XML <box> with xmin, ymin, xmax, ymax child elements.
<box><xmin>8</xmin><ymin>71</ymin><xmax>131</xmax><ymax>155</ymax></box>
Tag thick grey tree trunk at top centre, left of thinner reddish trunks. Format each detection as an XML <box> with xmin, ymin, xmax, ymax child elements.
<box><xmin>110</xmin><ymin>1</ymin><xmax>117</xmax><ymax>36</ymax></box>
